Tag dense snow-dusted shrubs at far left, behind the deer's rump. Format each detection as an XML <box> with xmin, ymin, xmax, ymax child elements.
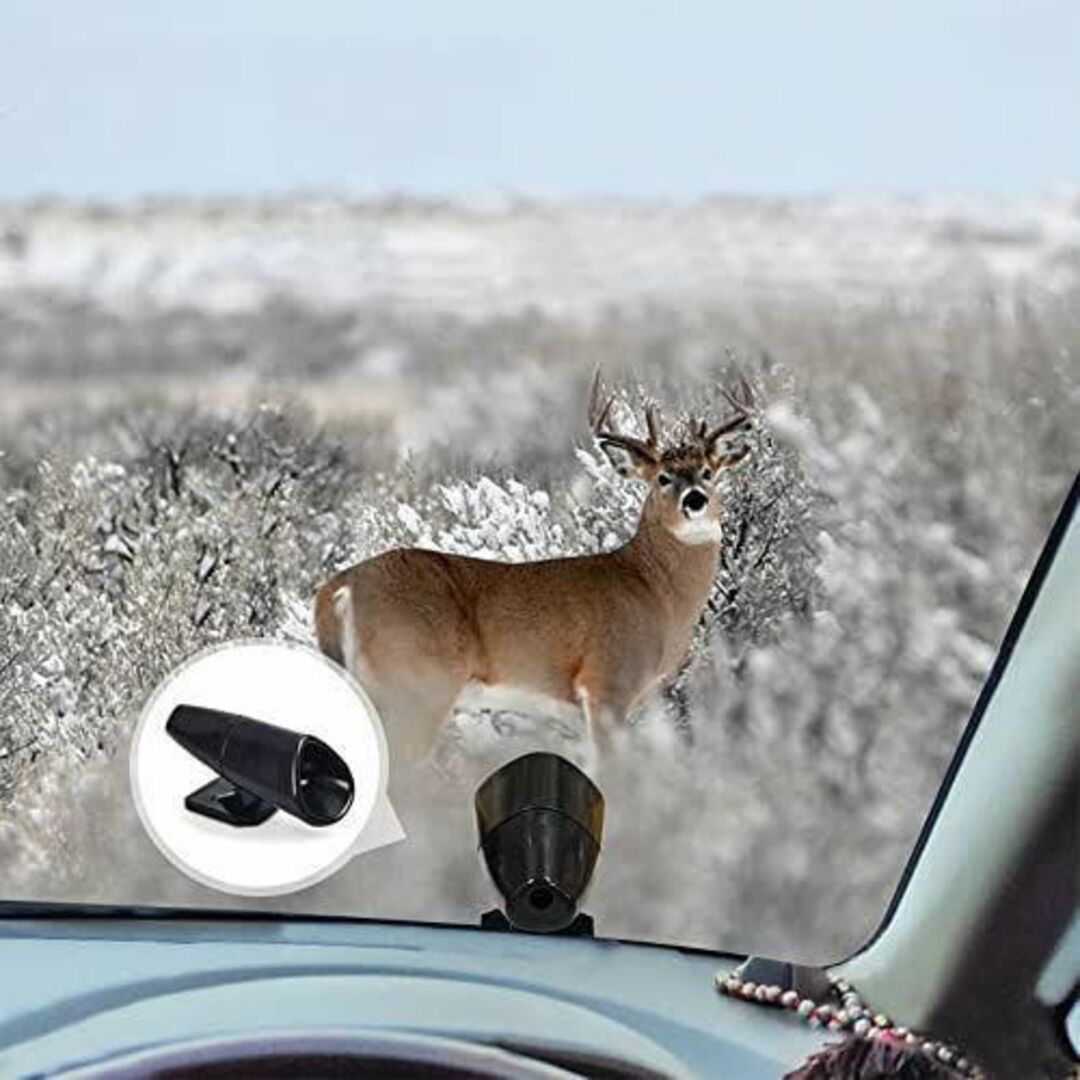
<box><xmin>0</xmin><ymin>413</ymin><xmax>362</xmax><ymax>791</ymax></box>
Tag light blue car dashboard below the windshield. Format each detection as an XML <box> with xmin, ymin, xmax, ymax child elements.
<box><xmin>0</xmin><ymin>914</ymin><xmax>821</xmax><ymax>1080</ymax></box>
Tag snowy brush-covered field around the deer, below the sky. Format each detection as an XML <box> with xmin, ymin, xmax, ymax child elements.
<box><xmin>0</xmin><ymin>192</ymin><xmax>1080</xmax><ymax>960</ymax></box>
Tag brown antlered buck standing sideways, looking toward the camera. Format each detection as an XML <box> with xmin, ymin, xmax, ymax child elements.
<box><xmin>315</xmin><ymin>373</ymin><xmax>752</xmax><ymax>760</ymax></box>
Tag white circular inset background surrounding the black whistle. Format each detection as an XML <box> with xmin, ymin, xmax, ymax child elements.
<box><xmin>131</xmin><ymin>642</ymin><xmax>388</xmax><ymax>896</ymax></box>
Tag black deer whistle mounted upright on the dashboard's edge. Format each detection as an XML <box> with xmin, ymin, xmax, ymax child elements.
<box><xmin>475</xmin><ymin>754</ymin><xmax>604</xmax><ymax>933</ymax></box>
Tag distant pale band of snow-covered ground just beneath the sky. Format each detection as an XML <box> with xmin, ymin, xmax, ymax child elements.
<box><xmin>0</xmin><ymin>192</ymin><xmax>1080</xmax><ymax>319</ymax></box>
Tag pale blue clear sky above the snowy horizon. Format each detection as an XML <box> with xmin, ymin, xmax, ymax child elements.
<box><xmin>0</xmin><ymin>0</ymin><xmax>1080</xmax><ymax>201</ymax></box>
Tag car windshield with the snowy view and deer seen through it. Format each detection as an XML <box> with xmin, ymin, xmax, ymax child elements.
<box><xmin>0</xmin><ymin>0</ymin><xmax>1080</xmax><ymax>961</ymax></box>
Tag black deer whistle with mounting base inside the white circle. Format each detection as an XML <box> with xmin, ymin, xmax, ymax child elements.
<box><xmin>165</xmin><ymin>705</ymin><xmax>354</xmax><ymax>826</ymax></box>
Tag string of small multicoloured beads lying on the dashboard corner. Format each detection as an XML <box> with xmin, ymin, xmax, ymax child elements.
<box><xmin>716</xmin><ymin>972</ymin><xmax>986</xmax><ymax>1080</ymax></box>
